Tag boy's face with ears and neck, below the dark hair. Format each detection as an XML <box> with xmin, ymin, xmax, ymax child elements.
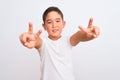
<box><xmin>43</xmin><ymin>11</ymin><xmax>65</xmax><ymax>40</ymax></box>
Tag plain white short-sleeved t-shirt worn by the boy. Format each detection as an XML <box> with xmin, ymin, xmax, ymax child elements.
<box><xmin>38</xmin><ymin>37</ymin><xmax>74</xmax><ymax>80</ymax></box>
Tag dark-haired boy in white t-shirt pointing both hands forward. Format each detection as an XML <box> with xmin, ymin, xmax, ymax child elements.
<box><xmin>20</xmin><ymin>6</ymin><xmax>100</xmax><ymax>80</ymax></box>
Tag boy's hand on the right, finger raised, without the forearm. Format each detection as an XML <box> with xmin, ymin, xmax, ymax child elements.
<box><xmin>79</xmin><ymin>18</ymin><xmax>100</xmax><ymax>41</ymax></box>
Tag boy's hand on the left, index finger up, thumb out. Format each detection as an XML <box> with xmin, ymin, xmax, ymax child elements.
<box><xmin>19</xmin><ymin>23</ymin><xmax>41</xmax><ymax>48</ymax></box>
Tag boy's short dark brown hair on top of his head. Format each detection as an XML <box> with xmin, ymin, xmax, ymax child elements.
<box><xmin>43</xmin><ymin>6</ymin><xmax>64</xmax><ymax>22</ymax></box>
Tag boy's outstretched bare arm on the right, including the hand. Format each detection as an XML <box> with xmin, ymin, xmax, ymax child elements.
<box><xmin>70</xmin><ymin>18</ymin><xmax>100</xmax><ymax>46</ymax></box>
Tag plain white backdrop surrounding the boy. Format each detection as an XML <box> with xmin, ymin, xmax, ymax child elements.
<box><xmin>0</xmin><ymin>0</ymin><xmax>120</xmax><ymax>80</ymax></box>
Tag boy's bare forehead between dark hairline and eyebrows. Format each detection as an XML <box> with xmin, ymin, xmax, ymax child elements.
<box><xmin>46</xmin><ymin>11</ymin><xmax>62</xmax><ymax>20</ymax></box>
